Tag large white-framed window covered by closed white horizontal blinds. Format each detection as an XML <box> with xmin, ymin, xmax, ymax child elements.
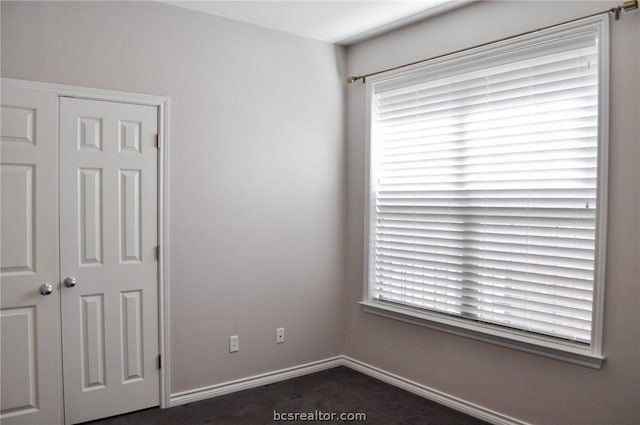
<box><xmin>363</xmin><ymin>17</ymin><xmax>608</xmax><ymax>367</ymax></box>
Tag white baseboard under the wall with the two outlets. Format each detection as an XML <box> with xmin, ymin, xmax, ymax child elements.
<box><xmin>169</xmin><ymin>356</ymin><xmax>343</xmax><ymax>407</ymax></box>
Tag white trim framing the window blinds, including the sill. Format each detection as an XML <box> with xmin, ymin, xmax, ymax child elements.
<box><xmin>359</xmin><ymin>15</ymin><xmax>610</xmax><ymax>369</ymax></box>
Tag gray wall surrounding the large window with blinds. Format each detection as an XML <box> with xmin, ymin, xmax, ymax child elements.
<box><xmin>345</xmin><ymin>2</ymin><xmax>640</xmax><ymax>425</ymax></box>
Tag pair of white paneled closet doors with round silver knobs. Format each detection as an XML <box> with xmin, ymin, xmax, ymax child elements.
<box><xmin>0</xmin><ymin>78</ymin><xmax>170</xmax><ymax>424</ymax></box>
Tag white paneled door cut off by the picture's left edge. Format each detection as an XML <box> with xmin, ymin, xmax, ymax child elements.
<box><xmin>0</xmin><ymin>86</ymin><xmax>62</xmax><ymax>425</ymax></box>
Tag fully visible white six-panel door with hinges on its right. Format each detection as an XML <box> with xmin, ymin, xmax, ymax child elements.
<box><xmin>60</xmin><ymin>97</ymin><xmax>160</xmax><ymax>423</ymax></box>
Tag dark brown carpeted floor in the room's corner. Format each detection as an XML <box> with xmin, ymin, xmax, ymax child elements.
<box><xmin>90</xmin><ymin>367</ymin><xmax>486</xmax><ymax>425</ymax></box>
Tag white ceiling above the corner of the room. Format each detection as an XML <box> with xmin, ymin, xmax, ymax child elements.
<box><xmin>165</xmin><ymin>0</ymin><xmax>469</xmax><ymax>45</ymax></box>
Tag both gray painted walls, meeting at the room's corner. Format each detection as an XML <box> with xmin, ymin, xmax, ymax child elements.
<box><xmin>1</xmin><ymin>1</ymin><xmax>640</xmax><ymax>425</ymax></box>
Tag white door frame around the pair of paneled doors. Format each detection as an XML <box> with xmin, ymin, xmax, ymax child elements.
<box><xmin>0</xmin><ymin>78</ymin><xmax>171</xmax><ymax>412</ymax></box>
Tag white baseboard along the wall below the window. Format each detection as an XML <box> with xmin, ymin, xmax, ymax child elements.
<box><xmin>342</xmin><ymin>356</ymin><xmax>530</xmax><ymax>425</ymax></box>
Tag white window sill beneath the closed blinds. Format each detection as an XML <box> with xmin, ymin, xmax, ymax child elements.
<box><xmin>359</xmin><ymin>301</ymin><xmax>605</xmax><ymax>369</ymax></box>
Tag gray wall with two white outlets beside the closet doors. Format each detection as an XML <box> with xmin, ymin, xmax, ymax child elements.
<box><xmin>1</xmin><ymin>1</ymin><xmax>344</xmax><ymax>393</ymax></box>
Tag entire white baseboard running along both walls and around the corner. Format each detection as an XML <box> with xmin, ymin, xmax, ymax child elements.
<box><xmin>169</xmin><ymin>356</ymin><xmax>531</xmax><ymax>425</ymax></box>
